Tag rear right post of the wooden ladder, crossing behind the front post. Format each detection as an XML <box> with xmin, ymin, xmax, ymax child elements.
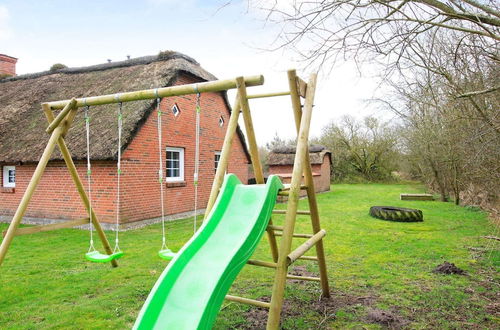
<box><xmin>288</xmin><ymin>70</ymin><xmax>330</xmax><ymax>298</ymax></box>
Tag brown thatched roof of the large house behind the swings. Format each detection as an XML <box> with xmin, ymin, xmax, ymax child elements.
<box><xmin>0</xmin><ymin>51</ymin><xmax>250</xmax><ymax>162</ymax></box>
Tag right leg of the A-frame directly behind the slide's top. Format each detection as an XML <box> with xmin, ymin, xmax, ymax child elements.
<box><xmin>236</xmin><ymin>77</ymin><xmax>278</xmax><ymax>262</ymax></box>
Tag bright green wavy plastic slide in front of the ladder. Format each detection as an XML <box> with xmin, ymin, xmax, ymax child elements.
<box><xmin>134</xmin><ymin>174</ymin><xmax>283</xmax><ymax>330</ymax></box>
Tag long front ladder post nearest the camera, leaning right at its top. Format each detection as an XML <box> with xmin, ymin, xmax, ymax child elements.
<box><xmin>267</xmin><ymin>74</ymin><xmax>317</xmax><ymax>329</ymax></box>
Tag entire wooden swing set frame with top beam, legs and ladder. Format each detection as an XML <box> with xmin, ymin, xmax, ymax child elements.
<box><xmin>0</xmin><ymin>70</ymin><xmax>330</xmax><ymax>329</ymax></box>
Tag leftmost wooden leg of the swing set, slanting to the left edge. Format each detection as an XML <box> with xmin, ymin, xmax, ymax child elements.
<box><xmin>0</xmin><ymin>114</ymin><xmax>74</xmax><ymax>265</ymax></box>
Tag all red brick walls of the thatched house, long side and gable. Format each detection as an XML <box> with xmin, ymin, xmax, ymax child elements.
<box><xmin>0</xmin><ymin>76</ymin><xmax>248</xmax><ymax>222</ymax></box>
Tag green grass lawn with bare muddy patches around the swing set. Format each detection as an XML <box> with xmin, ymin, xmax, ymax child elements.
<box><xmin>0</xmin><ymin>184</ymin><xmax>500</xmax><ymax>329</ymax></box>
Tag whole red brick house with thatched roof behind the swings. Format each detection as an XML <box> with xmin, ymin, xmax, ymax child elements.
<box><xmin>0</xmin><ymin>51</ymin><xmax>249</xmax><ymax>223</ymax></box>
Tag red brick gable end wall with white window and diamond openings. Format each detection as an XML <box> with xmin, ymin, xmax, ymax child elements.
<box><xmin>117</xmin><ymin>76</ymin><xmax>248</xmax><ymax>222</ymax></box>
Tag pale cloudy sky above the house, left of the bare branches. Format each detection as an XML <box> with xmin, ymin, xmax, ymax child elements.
<box><xmin>0</xmin><ymin>0</ymin><xmax>377</xmax><ymax>144</ymax></box>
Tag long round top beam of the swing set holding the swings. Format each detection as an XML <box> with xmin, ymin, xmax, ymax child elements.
<box><xmin>46</xmin><ymin>75</ymin><xmax>264</xmax><ymax>110</ymax></box>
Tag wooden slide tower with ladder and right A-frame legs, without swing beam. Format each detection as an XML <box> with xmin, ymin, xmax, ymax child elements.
<box><xmin>206</xmin><ymin>70</ymin><xmax>330</xmax><ymax>329</ymax></box>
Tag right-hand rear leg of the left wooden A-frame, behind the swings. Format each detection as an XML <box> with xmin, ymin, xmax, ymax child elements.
<box><xmin>42</xmin><ymin>104</ymin><xmax>118</xmax><ymax>267</ymax></box>
